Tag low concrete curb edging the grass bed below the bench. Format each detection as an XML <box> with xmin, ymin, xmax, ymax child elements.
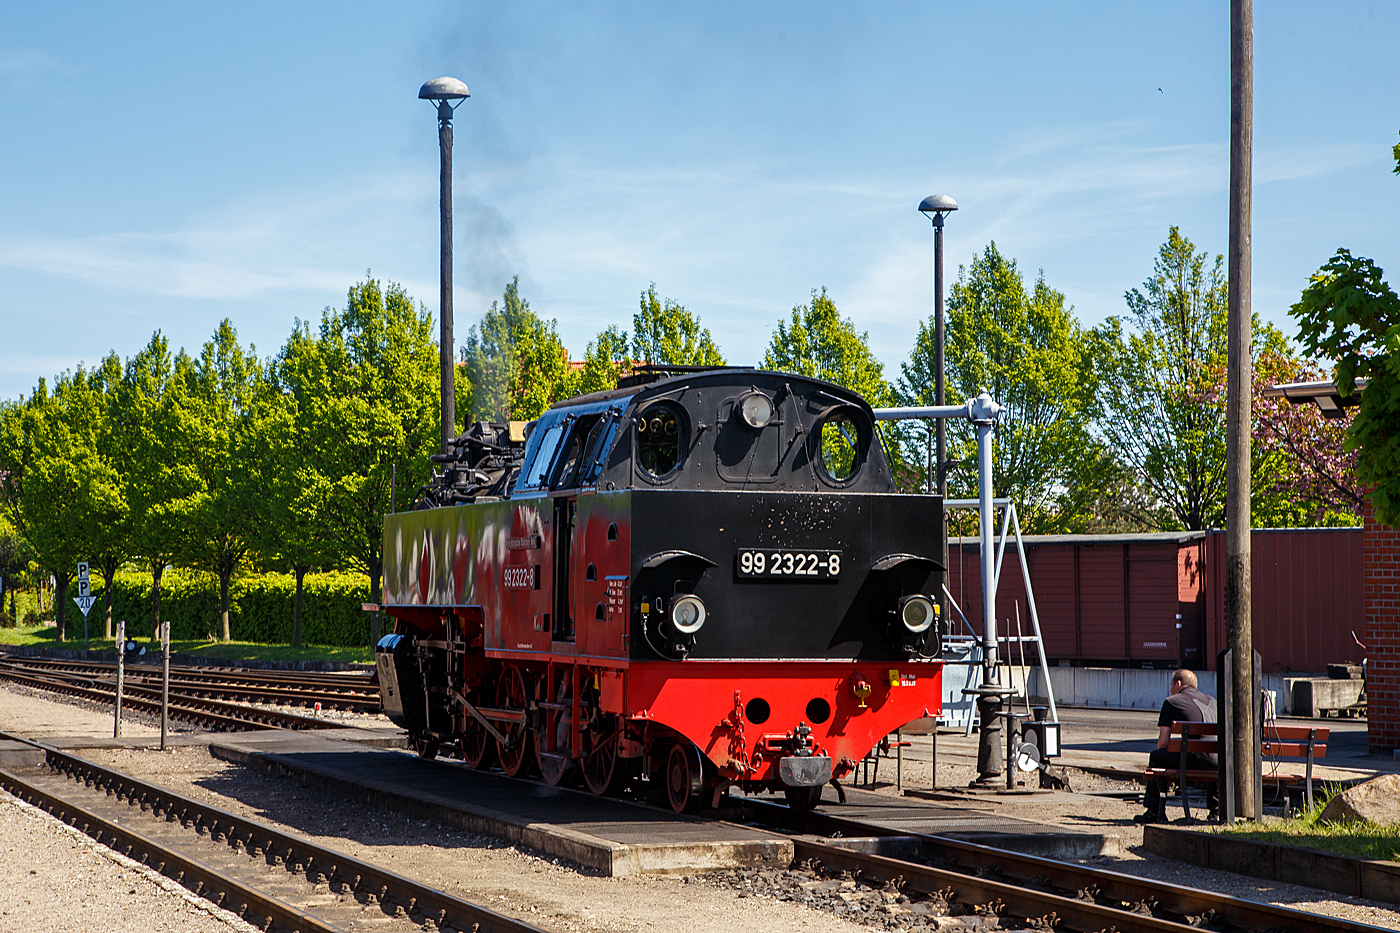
<box><xmin>1142</xmin><ymin>825</ymin><xmax>1400</xmax><ymax>904</ymax></box>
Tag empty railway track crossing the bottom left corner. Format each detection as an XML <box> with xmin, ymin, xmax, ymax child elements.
<box><xmin>0</xmin><ymin>733</ymin><xmax>542</xmax><ymax>933</ymax></box>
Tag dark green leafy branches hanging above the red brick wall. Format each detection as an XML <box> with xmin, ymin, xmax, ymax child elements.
<box><xmin>1289</xmin><ymin>246</ymin><xmax>1400</xmax><ymax>527</ymax></box>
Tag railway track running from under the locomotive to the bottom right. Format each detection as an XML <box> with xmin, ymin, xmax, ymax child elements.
<box><xmin>746</xmin><ymin>801</ymin><xmax>1382</xmax><ymax>933</ymax></box>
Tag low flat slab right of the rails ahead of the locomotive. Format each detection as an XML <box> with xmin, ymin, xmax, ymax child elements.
<box><xmin>784</xmin><ymin>787</ymin><xmax>1120</xmax><ymax>859</ymax></box>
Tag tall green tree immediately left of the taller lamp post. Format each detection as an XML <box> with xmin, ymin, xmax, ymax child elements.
<box><xmin>276</xmin><ymin>277</ymin><xmax>440</xmax><ymax>639</ymax></box>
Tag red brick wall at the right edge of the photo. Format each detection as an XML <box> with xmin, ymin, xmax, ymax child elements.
<box><xmin>1361</xmin><ymin>497</ymin><xmax>1400</xmax><ymax>752</ymax></box>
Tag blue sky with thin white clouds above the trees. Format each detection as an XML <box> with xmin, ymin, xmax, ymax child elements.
<box><xmin>0</xmin><ymin>1</ymin><xmax>1400</xmax><ymax>398</ymax></box>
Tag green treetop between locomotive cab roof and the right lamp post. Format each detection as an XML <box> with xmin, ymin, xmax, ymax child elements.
<box><xmin>763</xmin><ymin>282</ymin><xmax>893</xmax><ymax>408</ymax></box>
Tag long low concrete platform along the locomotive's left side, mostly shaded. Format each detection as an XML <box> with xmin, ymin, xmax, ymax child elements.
<box><xmin>210</xmin><ymin>733</ymin><xmax>792</xmax><ymax>876</ymax></box>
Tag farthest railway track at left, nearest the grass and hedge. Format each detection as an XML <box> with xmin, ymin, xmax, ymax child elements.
<box><xmin>0</xmin><ymin>656</ymin><xmax>381</xmax><ymax>713</ymax></box>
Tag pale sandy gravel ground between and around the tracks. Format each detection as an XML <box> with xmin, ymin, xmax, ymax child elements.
<box><xmin>0</xmin><ymin>685</ymin><xmax>1400</xmax><ymax>933</ymax></box>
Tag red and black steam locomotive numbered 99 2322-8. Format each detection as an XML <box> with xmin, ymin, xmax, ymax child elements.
<box><xmin>375</xmin><ymin>367</ymin><xmax>945</xmax><ymax>811</ymax></box>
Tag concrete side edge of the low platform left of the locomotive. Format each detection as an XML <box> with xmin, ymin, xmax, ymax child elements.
<box><xmin>209</xmin><ymin>742</ymin><xmax>794</xmax><ymax>877</ymax></box>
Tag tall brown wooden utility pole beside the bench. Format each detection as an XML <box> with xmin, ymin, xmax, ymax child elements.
<box><xmin>1222</xmin><ymin>0</ymin><xmax>1259</xmax><ymax>815</ymax></box>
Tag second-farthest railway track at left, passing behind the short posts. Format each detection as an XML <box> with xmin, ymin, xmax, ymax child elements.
<box><xmin>0</xmin><ymin>663</ymin><xmax>342</xmax><ymax>731</ymax></box>
